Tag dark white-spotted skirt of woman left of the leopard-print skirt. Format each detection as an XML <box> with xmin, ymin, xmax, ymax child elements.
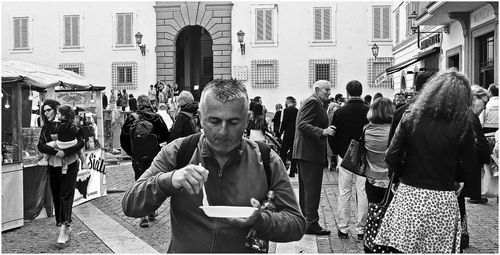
<box><xmin>363</xmin><ymin>175</ymin><xmax>394</xmax><ymax>253</ymax></box>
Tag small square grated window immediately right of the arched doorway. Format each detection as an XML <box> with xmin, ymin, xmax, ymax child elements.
<box><xmin>252</xmin><ymin>59</ymin><xmax>279</xmax><ymax>89</ymax></box>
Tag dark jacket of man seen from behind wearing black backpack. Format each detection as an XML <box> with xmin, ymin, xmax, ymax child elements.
<box><xmin>120</xmin><ymin>106</ymin><xmax>170</xmax><ymax>158</ymax></box>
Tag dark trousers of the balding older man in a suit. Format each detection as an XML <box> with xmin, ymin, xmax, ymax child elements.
<box><xmin>297</xmin><ymin>160</ymin><xmax>323</xmax><ymax>227</ymax></box>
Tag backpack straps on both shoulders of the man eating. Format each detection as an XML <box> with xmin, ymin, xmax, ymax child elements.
<box><xmin>177</xmin><ymin>133</ymin><xmax>271</xmax><ymax>185</ymax></box>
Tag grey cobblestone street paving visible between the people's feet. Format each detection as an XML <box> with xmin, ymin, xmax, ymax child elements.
<box><xmin>2</xmin><ymin>162</ymin><xmax>499</xmax><ymax>253</ymax></box>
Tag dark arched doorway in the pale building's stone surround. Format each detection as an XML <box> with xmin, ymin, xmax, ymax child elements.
<box><xmin>175</xmin><ymin>26</ymin><xmax>214</xmax><ymax>101</ymax></box>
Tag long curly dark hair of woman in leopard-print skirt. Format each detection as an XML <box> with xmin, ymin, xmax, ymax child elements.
<box><xmin>408</xmin><ymin>68</ymin><xmax>472</xmax><ymax>140</ymax></box>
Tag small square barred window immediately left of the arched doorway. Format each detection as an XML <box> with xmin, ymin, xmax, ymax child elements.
<box><xmin>111</xmin><ymin>61</ymin><xmax>137</xmax><ymax>90</ymax></box>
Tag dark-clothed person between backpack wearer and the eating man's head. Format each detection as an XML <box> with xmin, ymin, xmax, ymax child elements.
<box><xmin>168</xmin><ymin>90</ymin><xmax>199</xmax><ymax>142</ymax></box>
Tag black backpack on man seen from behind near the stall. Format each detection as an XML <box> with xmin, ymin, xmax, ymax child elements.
<box><xmin>130</xmin><ymin>113</ymin><xmax>160</xmax><ymax>161</ymax></box>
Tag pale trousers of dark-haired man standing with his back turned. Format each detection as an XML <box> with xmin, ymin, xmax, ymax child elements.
<box><xmin>338</xmin><ymin>154</ymin><xmax>368</xmax><ymax>234</ymax></box>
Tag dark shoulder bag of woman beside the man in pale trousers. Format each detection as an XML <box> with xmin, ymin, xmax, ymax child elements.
<box><xmin>340</xmin><ymin>126</ymin><xmax>366</xmax><ymax>177</ymax></box>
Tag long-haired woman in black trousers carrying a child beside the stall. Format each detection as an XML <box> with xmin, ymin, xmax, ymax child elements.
<box><xmin>37</xmin><ymin>99</ymin><xmax>84</xmax><ymax>244</ymax></box>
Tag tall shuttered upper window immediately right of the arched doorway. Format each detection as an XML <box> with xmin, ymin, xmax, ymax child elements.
<box><xmin>251</xmin><ymin>4</ymin><xmax>278</xmax><ymax>47</ymax></box>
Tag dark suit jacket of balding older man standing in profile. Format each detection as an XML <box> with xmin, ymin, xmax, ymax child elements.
<box><xmin>293</xmin><ymin>95</ymin><xmax>328</xmax><ymax>165</ymax></box>
